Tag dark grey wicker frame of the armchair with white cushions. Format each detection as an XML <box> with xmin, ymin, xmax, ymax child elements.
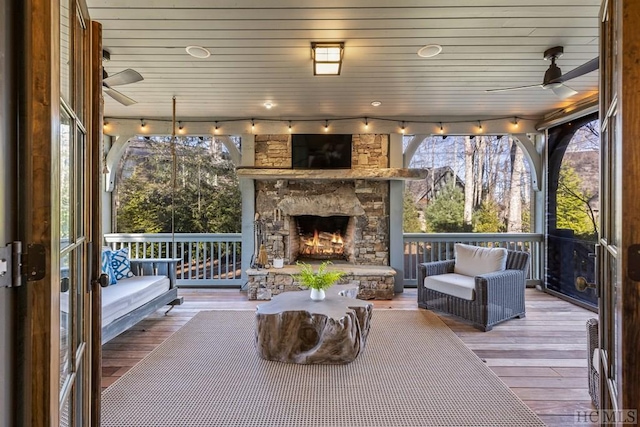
<box><xmin>418</xmin><ymin>250</ymin><xmax>529</xmax><ymax>331</ymax></box>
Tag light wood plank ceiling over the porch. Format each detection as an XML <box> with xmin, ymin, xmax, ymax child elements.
<box><xmin>87</xmin><ymin>0</ymin><xmax>600</xmax><ymax>120</ymax></box>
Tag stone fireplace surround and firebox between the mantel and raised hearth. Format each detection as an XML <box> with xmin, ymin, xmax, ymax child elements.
<box><xmin>256</xmin><ymin>180</ymin><xmax>389</xmax><ymax>266</ymax></box>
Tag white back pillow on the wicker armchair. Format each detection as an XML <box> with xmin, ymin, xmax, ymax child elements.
<box><xmin>453</xmin><ymin>243</ymin><xmax>507</xmax><ymax>277</ymax></box>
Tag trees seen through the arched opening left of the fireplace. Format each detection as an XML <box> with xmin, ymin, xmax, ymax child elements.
<box><xmin>116</xmin><ymin>141</ymin><xmax>242</xmax><ymax>233</ymax></box>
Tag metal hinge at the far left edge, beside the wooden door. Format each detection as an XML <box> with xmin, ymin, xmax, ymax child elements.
<box><xmin>0</xmin><ymin>242</ymin><xmax>46</xmax><ymax>288</ymax></box>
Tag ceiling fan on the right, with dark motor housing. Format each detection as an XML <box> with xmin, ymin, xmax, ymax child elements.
<box><xmin>485</xmin><ymin>46</ymin><xmax>598</xmax><ymax>99</ymax></box>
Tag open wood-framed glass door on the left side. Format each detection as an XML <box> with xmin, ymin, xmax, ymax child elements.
<box><xmin>16</xmin><ymin>0</ymin><xmax>99</xmax><ymax>427</ymax></box>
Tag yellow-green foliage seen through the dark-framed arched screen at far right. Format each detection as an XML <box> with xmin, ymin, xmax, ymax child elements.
<box><xmin>556</xmin><ymin>164</ymin><xmax>597</xmax><ymax>240</ymax></box>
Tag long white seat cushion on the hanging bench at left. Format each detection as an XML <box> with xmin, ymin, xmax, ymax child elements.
<box><xmin>102</xmin><ymin>276</ymin><xmax>170</xmax><ymax>326</ymax></box>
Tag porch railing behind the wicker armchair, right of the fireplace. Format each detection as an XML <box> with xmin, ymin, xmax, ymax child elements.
<box><xmin>404</xmin><ymin>233</ymin><xmax>544</xmax><ymax>286</ymax></box>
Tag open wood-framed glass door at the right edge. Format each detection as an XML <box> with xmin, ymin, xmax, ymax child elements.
<box><xmin>598</xmin><ymin>0</ymin><xmax>640</xmax><ymax>418</ymax></box>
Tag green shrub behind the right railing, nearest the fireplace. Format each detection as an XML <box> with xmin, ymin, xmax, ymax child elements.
<box><xmin>424</xmin><ymin>185</ymin><xmax>469</xmax><ymax>233</ymax></box>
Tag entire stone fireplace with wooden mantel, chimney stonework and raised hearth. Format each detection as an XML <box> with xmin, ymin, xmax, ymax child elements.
<box><xmin>238</xmin><ymin>134</ymin><xmax>424</xmax><ymax>299</ymax></box>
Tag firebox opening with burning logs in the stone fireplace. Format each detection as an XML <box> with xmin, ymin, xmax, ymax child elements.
<box><xmin>296</xmin><ymin>215</ymin><xmax>350</xmax><ymax>261</ymax></box>
